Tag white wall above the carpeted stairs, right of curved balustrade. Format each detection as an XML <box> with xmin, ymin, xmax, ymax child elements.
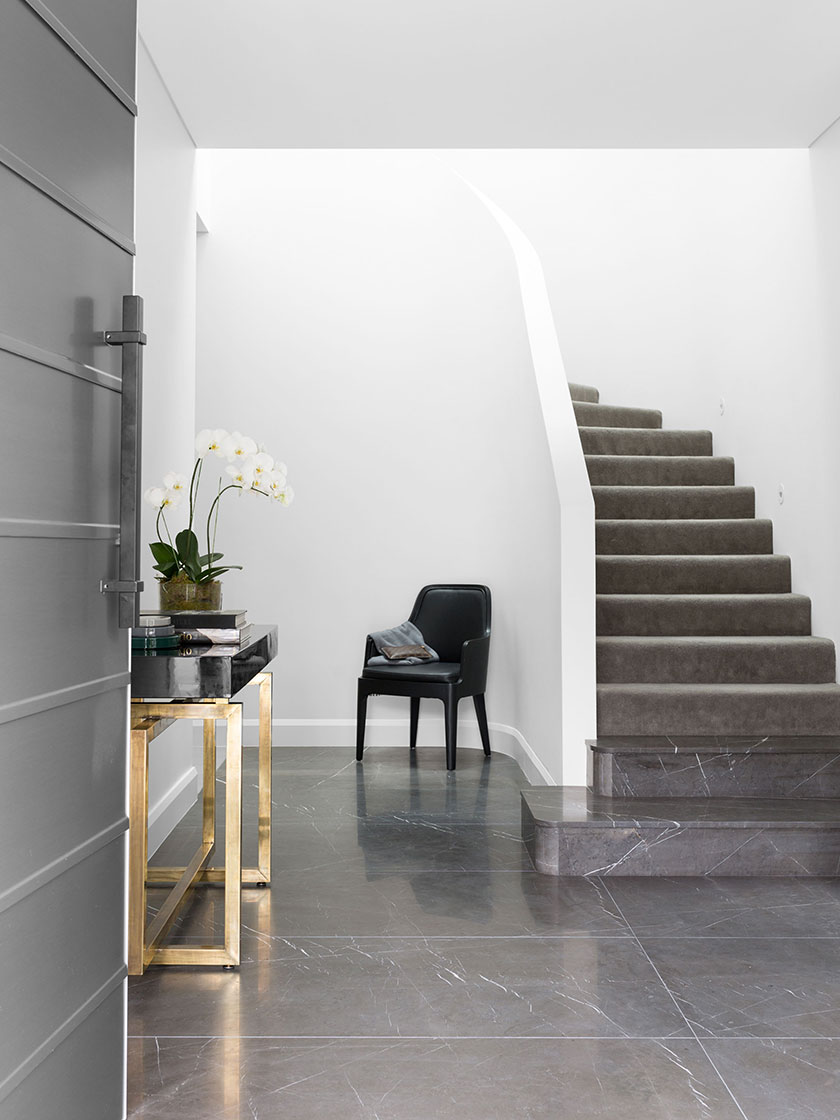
<box><xmin>441</xmin><ymin>148</ymin><xmax>840</xmax><ymax>654</ymax></box>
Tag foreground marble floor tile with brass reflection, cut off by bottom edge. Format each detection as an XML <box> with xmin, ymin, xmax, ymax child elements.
<box><xmin>129</xmin><ymin>1038</ymin><xmax>743</xmax><ymax>1120</ymax></box>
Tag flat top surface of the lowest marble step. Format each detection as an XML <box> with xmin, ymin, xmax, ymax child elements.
<box><xmin>522</xmin><ymin>786</ymin><xmax>840</xmax><ymax>829</ymax></box>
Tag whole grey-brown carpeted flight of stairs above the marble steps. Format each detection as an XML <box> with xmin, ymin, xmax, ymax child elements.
<box><xmin>569</xmin><ymin>385</ymin><xmax>840</xmax><ymax>736</ymax></box>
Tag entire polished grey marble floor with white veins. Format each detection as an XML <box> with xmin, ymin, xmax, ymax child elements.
<box><xmin>128</xmin><ymin>748</ymin><xmax>840</xmax><ymax>1120</ymax></box>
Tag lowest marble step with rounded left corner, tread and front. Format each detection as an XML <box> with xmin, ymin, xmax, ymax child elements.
<box><xmin>522</xmin><ymin>786</ymin><xmax>840</xmax><ymax>877</ymax></box>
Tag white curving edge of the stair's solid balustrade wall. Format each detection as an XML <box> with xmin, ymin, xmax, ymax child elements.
<box><xmin>441</xmin><ymin>160</ymin><xmax>597</xmax><ymax>785</ymax></box>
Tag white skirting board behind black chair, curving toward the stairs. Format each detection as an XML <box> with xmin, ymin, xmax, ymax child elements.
<box><xmin>224</xmin><ymin>717</ymin><xmax>553</xmax><ymax>785</ymax></box>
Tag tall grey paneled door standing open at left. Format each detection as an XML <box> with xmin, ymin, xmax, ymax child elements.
<box><xmin>0</xmin><ymin>0</ymin><xmax>137</xmax><ymax>1120</ymax></box>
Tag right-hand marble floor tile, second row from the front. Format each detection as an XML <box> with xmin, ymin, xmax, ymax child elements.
<box><xmin>642</xmin><ymin>937</ymin><xmax>840</xmax><ymax>1038</ymax></box>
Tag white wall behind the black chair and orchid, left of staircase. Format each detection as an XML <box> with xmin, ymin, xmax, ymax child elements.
<box><xmin>197</xmin><ymin>151</ymin><xmax>584</xmax><ymax>781</ymax></box>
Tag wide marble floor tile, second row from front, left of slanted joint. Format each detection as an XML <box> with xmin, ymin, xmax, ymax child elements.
<box><xmin>129</xmin><ymin>936</ymin><xmax>690</xmax><ymax>1037</ymax></box>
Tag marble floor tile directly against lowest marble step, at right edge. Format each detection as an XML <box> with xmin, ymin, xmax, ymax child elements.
<box><xmin>607</xmin><ymin>877</ymin><xmax>840</xmax><ymax>937</ymax></box>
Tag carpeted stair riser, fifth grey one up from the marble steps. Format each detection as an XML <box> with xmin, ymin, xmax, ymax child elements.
<box><xmin>595</xmin><ymin>519</ymin><xmax>773</xmax><ymax>556</ymax></box>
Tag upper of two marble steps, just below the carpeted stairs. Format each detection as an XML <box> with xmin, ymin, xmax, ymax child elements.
<box><xmin>588</xmin><ymin>735</ymin><xmax>840</xmax><ymax>797</ymax></box>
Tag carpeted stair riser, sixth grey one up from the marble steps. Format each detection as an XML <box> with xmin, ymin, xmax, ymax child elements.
<box><xmin>592</xmin><ymin>486</ymin><xmax>755</xmax><ymax>521</ymax></box>
